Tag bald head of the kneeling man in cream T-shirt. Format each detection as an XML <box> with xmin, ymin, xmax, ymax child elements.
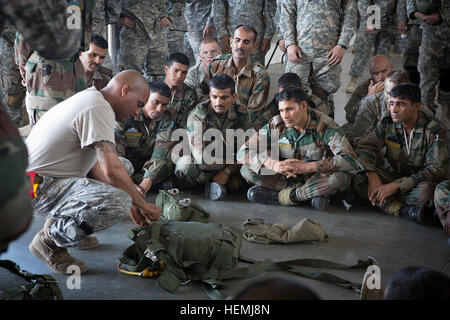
<box><xmin>101</xmin><ymin>70</ymin><xmax>150</xmax><ymax>121</ymax></box>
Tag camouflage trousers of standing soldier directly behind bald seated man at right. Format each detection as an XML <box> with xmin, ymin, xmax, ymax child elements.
<box><xmin>349</xmin><ymin>27</ymin><xmax>392</xmax><ymax>77</ymax></box>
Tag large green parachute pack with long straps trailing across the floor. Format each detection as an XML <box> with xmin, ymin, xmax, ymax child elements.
<box><xmin>118</xmin><ymin>219</ymin><xmax>375</xmax><ymax>299</ymax></box>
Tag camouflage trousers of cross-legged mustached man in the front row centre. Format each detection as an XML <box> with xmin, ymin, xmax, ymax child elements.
<box><xmin>175</xmin><ymin>156</ymin><xmax>243</xmax><ymax>192</ymax></box>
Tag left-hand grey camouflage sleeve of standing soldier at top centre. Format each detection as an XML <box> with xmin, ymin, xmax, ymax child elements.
<box><xmin>279</xmin><ymin>0</ymin><xmax>297</xmax><ymax>48</ymax></box>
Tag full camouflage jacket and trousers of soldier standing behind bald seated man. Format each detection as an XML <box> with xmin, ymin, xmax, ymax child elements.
<box><xmin>349</xmin><ymin>0</ymin><xmax>396</xmax><ymax>78</ymax></box>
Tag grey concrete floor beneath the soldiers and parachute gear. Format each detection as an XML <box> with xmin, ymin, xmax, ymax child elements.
<box><xmin>0</xmin><ymin>42</ymin><xmax>450</xmax><ymax>300</ymax></box>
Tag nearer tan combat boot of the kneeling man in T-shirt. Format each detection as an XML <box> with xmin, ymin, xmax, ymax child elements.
<box><xmin>28</xmin><ymin>229</ymin><xmax>87</xmax><ymax>274</ymax></box>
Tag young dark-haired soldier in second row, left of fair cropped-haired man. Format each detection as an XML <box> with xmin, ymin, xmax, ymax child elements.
<box><xmin>164</xmin><ymin>52</ymin><xmax>198</xmax><ymax>128</ymax></box>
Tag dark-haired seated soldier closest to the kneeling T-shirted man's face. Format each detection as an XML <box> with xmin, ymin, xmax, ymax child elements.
<box><xmin>115</xmin><ymin>81</ymin><xmax>174</xmax><ymax>197</ymax></box>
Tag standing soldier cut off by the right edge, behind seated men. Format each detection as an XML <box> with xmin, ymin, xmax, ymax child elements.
<box><xmin>407</xmin><ymin>0</ymin><xmax>450</xmax><ymax>124</ymax></box>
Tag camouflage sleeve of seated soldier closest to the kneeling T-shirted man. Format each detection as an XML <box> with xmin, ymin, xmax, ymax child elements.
<box><xmin>144</xmin><ymin>119</ymin><xmax>175</xmax><ymax>181</ymax></box>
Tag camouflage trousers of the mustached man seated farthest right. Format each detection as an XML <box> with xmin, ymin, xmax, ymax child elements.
<box><xmin>352</xmin><ymin>167</ymin><xmax>436</xmax><ymax>217</ymax></box>
